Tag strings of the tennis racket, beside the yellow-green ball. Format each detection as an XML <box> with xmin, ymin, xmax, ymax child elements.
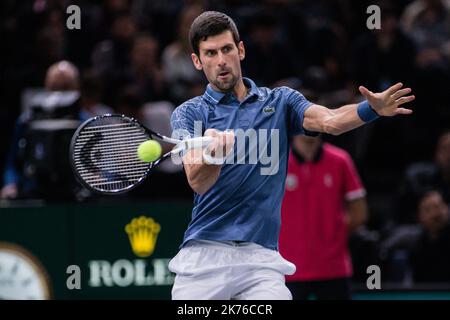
<box><xmin>73</xmin><ymin>117</ymin><xmax>149</xmax><ymax>192</ymax></box>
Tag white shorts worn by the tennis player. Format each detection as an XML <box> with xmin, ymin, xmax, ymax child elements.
<box><xmin>169</xmin><ymin>240</ymin><xmax>295</xmax><ymax>300</ymax></box>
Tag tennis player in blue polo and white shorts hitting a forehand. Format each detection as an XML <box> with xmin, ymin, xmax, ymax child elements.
<box><xmin>169</xmin><ymin>11</ymin><xmax>414</xmax><ymax>300</ymax></box>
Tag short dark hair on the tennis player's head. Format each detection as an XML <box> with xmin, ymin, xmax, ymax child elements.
<box><xmin>189</xmin><ymin>11</ymin><xmax>239</xmax><ymax>55</ymax></box>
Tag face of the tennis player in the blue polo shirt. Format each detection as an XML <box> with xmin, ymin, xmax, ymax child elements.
<box><xmin>192</xmin><ymin>30</ymin><xmax>245</xmax><ymax>92</ymax></box>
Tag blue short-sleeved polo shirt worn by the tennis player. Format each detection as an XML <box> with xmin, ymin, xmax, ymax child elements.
<box><xmin>171</xmin><ymin>78</ymin><xmax>312</xmax><ymax>250</ymax></box>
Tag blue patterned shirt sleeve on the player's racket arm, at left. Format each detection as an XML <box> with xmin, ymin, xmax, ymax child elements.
<box><xmin>170</xmin><ymin>101</ymin><xmax>205</xmax><ymax>139</ymax></box>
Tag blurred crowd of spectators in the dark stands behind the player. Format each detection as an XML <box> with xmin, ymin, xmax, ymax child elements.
<box><xmin>0</xmin><ymin>0</ymin><xmax>450</xmax><ymax>284</ymax></box>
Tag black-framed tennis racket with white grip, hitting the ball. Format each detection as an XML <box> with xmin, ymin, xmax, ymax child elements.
<box><xmin>70</xmin><ymin>114</ymin><xmax>213</xmax><ymax>194</ymax></box>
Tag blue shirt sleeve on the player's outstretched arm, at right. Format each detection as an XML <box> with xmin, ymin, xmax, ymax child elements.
<box><xmin>283</xmin><ymin>87</ymin><xmax>318</xmax><ymax>136</ymax></box>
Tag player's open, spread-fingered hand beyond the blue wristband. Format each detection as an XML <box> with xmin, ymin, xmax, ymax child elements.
<box><xmin>359</xmin><ymin>82</ymin><xmax>415</xmax><ymax>117</ymax></box>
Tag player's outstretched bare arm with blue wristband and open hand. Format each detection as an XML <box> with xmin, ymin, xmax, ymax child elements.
<box><xmin>303</xmin><ymin>83</ymin><xmax>415</xmax><ymax>135</ymax></box>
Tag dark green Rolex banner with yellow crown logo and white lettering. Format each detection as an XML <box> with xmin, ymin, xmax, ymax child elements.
<box><xmin>0</xmin><ymin>203</ymin><xmax>192</xmax><ymax>299</ymax></box>
